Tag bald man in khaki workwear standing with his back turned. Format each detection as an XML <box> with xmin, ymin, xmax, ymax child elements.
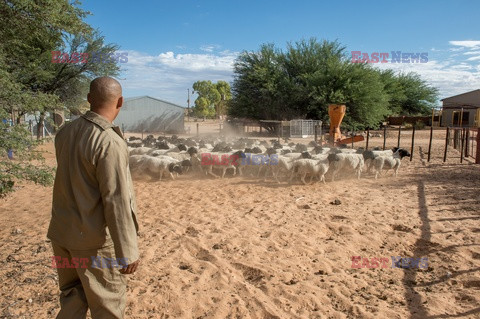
<box><xmin>47</xmin><ymin>77</ymin><xmax>139</xmax><ymax>319</ymax></box>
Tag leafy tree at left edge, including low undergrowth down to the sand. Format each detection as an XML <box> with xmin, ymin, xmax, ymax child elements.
<box><xmin>0</xmin><ymin>0</ymin><xmax>125</xmax><ymax>195</ymax></box>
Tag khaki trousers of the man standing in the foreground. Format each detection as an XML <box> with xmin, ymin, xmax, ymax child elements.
<box><xmin>52</xmin><ymin>241</ymin><xmax>127</xmax><ymax>319</ymax></box>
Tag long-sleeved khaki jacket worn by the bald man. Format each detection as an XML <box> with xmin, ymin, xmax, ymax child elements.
<box><xmin>47</xmin><ymin>111</ymin><xmax>139</xmax><ymax>263</ymax></box>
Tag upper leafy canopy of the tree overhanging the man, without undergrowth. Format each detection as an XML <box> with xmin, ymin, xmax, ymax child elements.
<box><xmin>0</xmin><ymin>0</ymin><xmax>123</xmax><ymax>139</ymax></box>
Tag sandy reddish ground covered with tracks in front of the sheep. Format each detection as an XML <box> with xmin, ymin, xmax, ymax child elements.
<box><xmin>0</xmin><ymin>124</ymin><xmax>480</xmax><ymax>318</ymax></box>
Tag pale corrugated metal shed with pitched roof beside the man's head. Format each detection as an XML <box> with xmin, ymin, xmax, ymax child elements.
<box><xmin>115</xmin><ymin>96</ymin><xmax>185</xmax><ymax>133</ymax></box>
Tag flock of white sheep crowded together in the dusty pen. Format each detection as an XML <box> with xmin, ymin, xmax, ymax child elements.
<box><xmin>127</xmin><ymin>135</ymin><xmax>410</xmax><ymax>184</ymax></box>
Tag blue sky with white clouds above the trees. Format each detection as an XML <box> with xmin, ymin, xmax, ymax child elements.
<box><xmin>81</xmin><ymin>0</ymin><xmax>480</xmax><ymax>106</ymax></box>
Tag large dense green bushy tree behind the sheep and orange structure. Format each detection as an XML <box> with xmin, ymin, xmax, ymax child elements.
<box><xmin>228</xmin><ymin>38</ymin><xmax>437</xmax><ymax>129</ymax></box>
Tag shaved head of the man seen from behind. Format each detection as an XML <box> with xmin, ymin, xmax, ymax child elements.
<box><xmin>88</xmin><ymin>76</ymin><xmax>123</xmax><ymax>121</ymax></box>
